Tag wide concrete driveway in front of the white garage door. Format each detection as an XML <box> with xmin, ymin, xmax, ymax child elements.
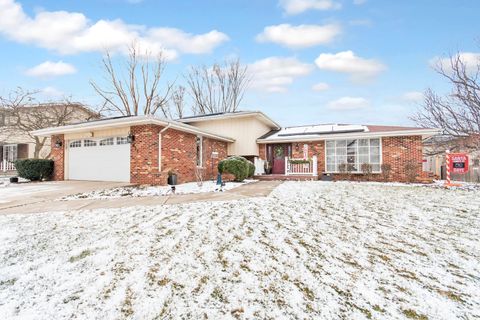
<box><xmin>0</xmin><ymin>181</ymin><xmax>129</xmax><ymax>213</ymax></box>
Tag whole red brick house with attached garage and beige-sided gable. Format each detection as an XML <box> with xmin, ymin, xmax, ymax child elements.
<box><xmin>34</xmin><ymin>111</ymin><xmax>439</xmax><ymax>185</ymax></box>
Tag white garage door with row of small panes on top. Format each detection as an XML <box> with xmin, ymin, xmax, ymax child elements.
<box><xmin>67</xmin><ymin>137</ymin><xmax>130</xmax><ymax>182</ymax></box>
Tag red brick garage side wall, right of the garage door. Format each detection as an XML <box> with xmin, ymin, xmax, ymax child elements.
<box><xmin>130</xmin><ymin>125</ymin><xmax>227</xmax><ymax>185</ymax></box>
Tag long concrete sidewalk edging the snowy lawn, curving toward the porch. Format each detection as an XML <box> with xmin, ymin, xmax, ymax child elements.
<box><xmin>0</xmin><ymin>181</ymin><xmax>282</xmax><ymax>214</ymax></box>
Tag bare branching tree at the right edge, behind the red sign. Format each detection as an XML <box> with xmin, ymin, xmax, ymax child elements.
<box><xmin>412</xmin><ymin>53</ymin><xmax>480</xmax><ymax>152</ymax></box>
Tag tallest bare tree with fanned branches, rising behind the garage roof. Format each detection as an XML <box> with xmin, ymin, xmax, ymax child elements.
<box><xmin>90</xmin><ymin>43</ymin><xmax>173</xmax><ymax>116</ymax></box>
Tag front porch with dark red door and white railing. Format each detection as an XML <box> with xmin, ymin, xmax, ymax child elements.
<box><xmin>254</xmin><ymin>143</ymin><xmax>318</xmax><ymax>180</ymax></box>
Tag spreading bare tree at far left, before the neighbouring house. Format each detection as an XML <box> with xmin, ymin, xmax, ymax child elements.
<box><xmin>0</xmin><ymin>88</ymin><xmax>99</xmax><ymax>158</ymax></box>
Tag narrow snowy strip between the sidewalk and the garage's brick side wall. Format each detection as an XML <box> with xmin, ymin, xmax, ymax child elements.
<box><xmin>61</xmin><ymin>180</ymin><xmax>256</xmax><ymax>200</ymax></box>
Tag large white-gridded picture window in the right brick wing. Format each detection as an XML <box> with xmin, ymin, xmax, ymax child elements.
<box><xmin>325</xmin><ymin>139</ymin><xmax>381</xmax><ymax>173</ymax></box>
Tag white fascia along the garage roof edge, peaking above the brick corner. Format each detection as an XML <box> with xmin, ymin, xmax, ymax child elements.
<box><xmin>31</xmin><ymin>116</ymin><xmax>235</xmax><ymax>142</ymax></box>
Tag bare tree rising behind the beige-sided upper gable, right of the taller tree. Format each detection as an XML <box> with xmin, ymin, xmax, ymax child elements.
<box><xmin>186</xmin><ymin>59</ymin><xmax>249</xmax><ymax>114</ymax></box>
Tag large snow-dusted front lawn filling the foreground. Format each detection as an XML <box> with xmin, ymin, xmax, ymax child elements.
<box><xmin>0</xmin><ymin>182</ymin><xmax>480</xmax><ymax>319</ymax></box>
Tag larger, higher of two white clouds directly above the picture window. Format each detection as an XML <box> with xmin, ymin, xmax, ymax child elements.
<box><xmin>315</xmin><ymin>51</ymin><xmax>386</xmax><ymax>82</ymax></box>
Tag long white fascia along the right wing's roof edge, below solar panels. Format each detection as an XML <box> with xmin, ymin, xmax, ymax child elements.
<box><xmin>257</xmin><ymin>129</ymin><xmax>442</xmax><ymax>143</ymax></box>
